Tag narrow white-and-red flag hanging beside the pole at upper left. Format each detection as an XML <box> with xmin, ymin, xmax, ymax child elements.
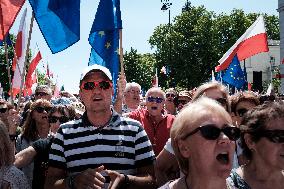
<box><xmin>12</xmin><ymin>9</ymin><xmax>27</xmax><ymax>96</ymax></box>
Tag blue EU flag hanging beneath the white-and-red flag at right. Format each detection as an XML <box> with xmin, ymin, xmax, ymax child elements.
<box><xmin>223</xmin><ymin>55</ymin><xmax>246</xmax><ymax>89</ymax></box>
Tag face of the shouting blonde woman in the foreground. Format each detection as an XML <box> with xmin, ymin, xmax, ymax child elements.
<box><xmin>179</xmin><ymin>112</ymin><xmax>235</xmax><ymax>179</ymax></box>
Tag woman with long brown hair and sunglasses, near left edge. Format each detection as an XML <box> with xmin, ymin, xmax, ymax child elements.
<box><xmin>16</xmin><ymin>99</ymin><xmax>52</xmax><ymax>185</ymax></box>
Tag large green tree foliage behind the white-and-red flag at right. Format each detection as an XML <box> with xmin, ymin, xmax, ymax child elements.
<box><xmin>149</xmin><ymin>5</ymin><xmax>280</xmax><ymax>89</ymax></box>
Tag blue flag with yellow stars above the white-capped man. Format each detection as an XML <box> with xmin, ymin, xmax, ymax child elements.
<box><xmin>89</xmin><ymin>0</ymin><xmax>122</xmax><ymax>96</ymax></box>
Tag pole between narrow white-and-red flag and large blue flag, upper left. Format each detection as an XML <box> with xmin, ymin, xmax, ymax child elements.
<box><xmin>17</xmin><ymin>12</ymin><xmax>35</xmax><ymax>112</ymax></box>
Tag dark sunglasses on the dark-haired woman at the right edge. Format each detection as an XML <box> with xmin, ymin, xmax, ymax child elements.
<box><xmin>256</xmin><ymin>130</ymin><xmax>284</xmax><ymax>143</ymax></box>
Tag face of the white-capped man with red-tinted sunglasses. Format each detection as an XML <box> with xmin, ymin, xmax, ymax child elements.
<box><xmin>79</xmin><ymin>72</ymin><xmax>113</xmax><ymax>112</ymax></box>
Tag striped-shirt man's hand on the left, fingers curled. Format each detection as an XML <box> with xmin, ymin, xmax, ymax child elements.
<box><xmin>74</xmin><ymin>165</ymin><xmax>105</xmax><ymax>189</ymax></box>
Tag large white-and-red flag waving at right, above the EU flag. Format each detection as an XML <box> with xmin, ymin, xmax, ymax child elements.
<box><xmin>215</xmin><ymin>16</ymin><xmax>269</xmax><ymax>71</ymax></box>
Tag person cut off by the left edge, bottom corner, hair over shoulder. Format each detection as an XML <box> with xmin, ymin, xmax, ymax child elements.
<box><xmin>0</xmin><ymin>121</ymin><xmax>30</xmax><ymax>189</ymax></box>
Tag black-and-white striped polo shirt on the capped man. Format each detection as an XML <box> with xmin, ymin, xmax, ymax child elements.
<box><xmin>49</xmin><ymin>110</ymin><xmax>155</xmax><ymax>176</ymax></box>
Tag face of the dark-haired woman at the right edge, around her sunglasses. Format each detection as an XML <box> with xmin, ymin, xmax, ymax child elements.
<box><xmin>252</xmin><ymin>118</ymin><xmax>284</xmax><ymax>171</ymax></box>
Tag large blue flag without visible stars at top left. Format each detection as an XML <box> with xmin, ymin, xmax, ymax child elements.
<box><xmin>29</xmin><ymin>0</ymin><xmax>80</xmax><ymax>54</ymax></box>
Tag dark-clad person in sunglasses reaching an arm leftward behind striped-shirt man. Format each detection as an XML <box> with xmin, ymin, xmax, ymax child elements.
<box><xmin>14</xmin><ymin>105</ymin><xmax>73</xmax><ymax>189</ymax></box>
